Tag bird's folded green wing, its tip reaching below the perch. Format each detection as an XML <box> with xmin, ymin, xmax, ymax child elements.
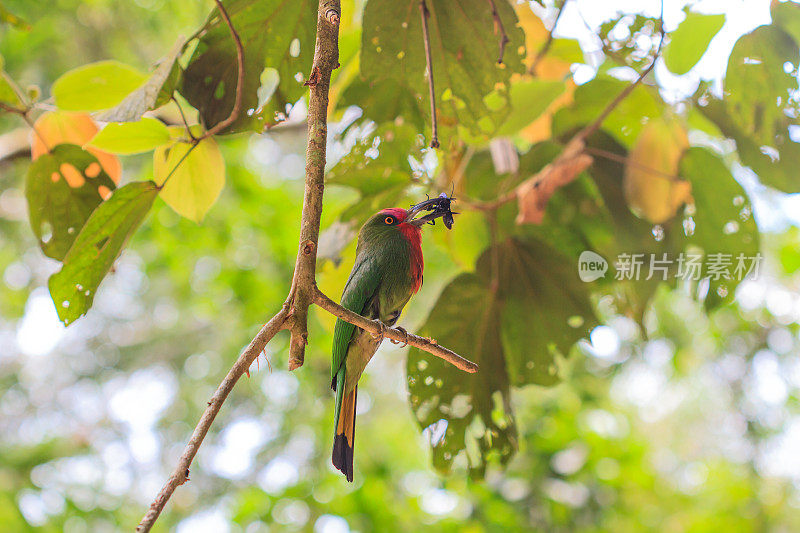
<box><xmin>331</xmin><ymin>257</ymin><xmax>381</xmax><ymax>379</ymax></box>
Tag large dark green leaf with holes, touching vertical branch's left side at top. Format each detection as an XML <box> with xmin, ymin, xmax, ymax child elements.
<box><xmin>180</xmin><ymin>0</ymin><xmax>317</xmax><ymax>133</ymax></box>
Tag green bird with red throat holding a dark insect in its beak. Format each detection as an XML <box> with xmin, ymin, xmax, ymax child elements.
<box><xmin>331</xmin><ymin>195</ymin><xmax>451</xmax><ymax>482</ymax></box>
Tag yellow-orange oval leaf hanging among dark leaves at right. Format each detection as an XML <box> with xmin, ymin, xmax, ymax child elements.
<box><xmin>623</xmin><ymin>118</ymin><xmax>692</xmax><ymax>224</ymax></box>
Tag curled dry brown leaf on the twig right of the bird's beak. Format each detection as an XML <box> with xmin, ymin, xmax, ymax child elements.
<box><xmin>517</xmin><ymin>140</ymin><xmax>592</xmax><ymax>224</ymax></box>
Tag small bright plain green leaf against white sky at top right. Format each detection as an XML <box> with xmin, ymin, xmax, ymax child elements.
<box><xmin>664</xmin><ymin>11</ymin><xmax>725</xmax><ymax>74</ymax></box>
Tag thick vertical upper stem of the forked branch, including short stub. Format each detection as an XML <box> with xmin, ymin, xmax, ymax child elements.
<box><xmin>289</xmin><ymin>0</ymin><xmax>342</xmax><ymax>370</ymax></box>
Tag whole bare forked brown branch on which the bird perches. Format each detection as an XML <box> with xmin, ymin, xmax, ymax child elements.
<box><xmin>136</xmin><ymin>0</ymin><xmax>478</xmax><ymax>533</ymax></box>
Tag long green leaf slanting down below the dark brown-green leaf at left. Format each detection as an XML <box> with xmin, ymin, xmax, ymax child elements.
<box><xmin>48</xmin><ymin>181</ymin><xmax>158</xmax><ymax>325</ymax></box>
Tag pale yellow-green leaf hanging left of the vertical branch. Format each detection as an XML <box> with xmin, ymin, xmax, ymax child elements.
<box><xmin>153</xmin><ymin>137</ymin><xmax>225</xmax><ymax>222</ymax></box>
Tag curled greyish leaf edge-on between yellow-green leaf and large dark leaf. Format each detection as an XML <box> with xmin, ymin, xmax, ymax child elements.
<box><xmin>97</xmin><ymin>40</ymin><xmax>184</xmax><ymax>122</ymax></box>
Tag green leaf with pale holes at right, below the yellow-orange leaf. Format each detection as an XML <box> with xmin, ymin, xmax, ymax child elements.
<box><xmin>680</xmin><ymin>148</ymin><xmax>759</xmax><ymax>307</ymax></box>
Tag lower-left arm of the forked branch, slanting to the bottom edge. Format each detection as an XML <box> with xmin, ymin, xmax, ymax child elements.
<box><xmin>136</xmin><ymin>304</ymin><xmax>289</xmax><ymax>533</ymax></box>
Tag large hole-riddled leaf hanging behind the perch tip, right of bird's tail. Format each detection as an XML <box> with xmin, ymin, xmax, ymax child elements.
<box><xmin>408</xmin><ymin>274</ymin><xmax>517</xmax><ymax>477</ymax></box>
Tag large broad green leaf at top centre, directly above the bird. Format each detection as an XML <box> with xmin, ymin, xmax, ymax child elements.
<box><xmin>361</xmin><ymin>0</ymin><xmax>525</xmax><ymax>141</ymax></box>
